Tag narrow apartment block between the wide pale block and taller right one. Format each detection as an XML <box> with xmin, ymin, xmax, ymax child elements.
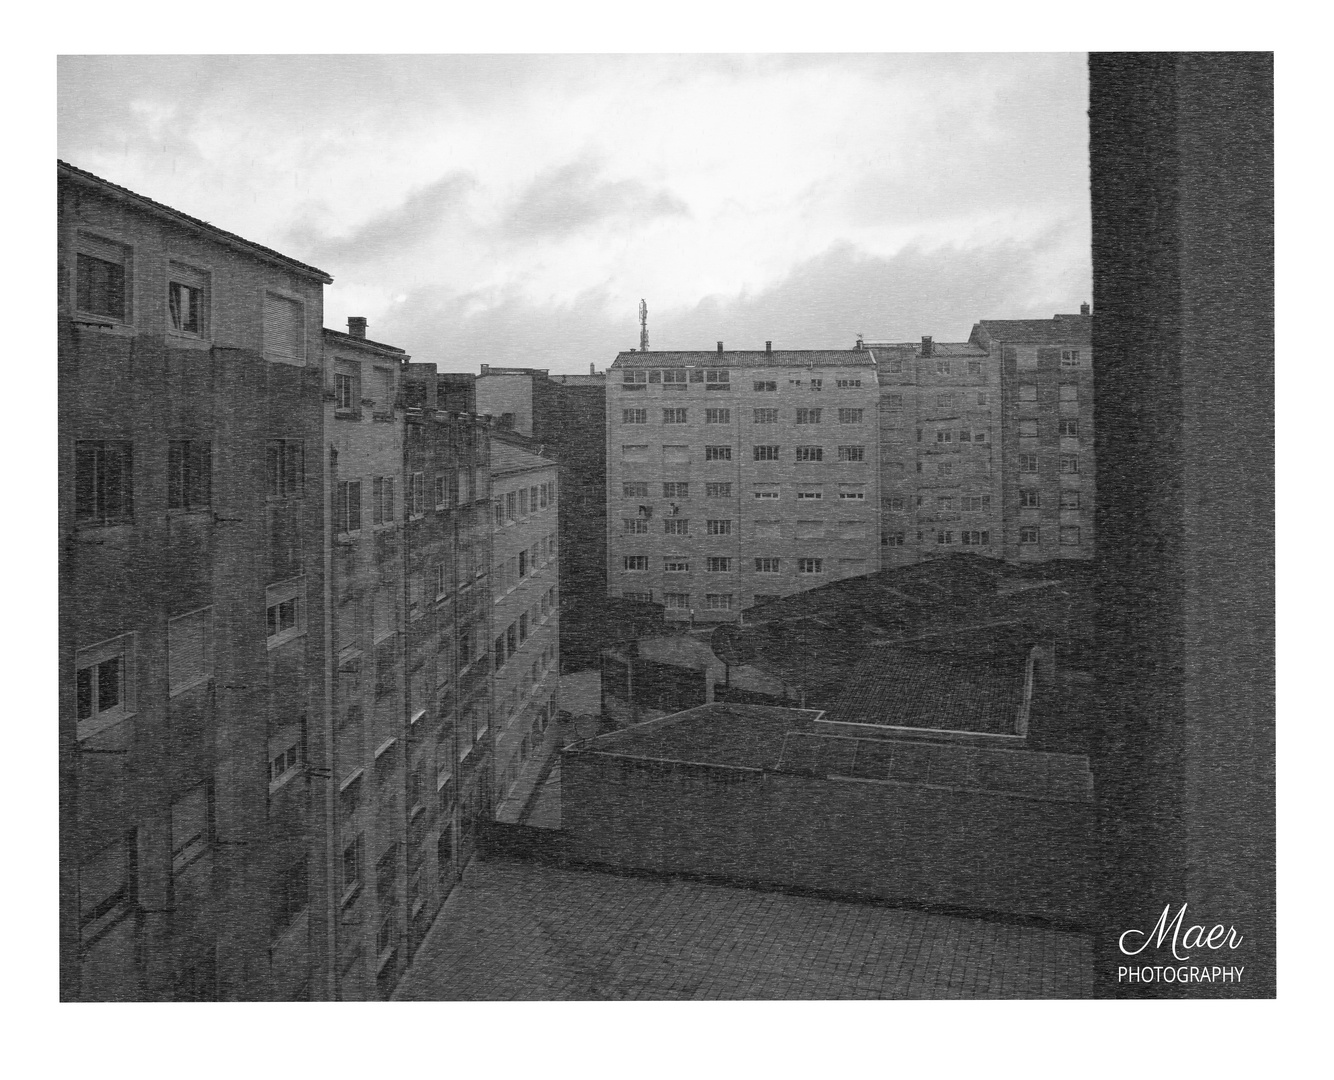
<box><xmin>864</xmin><ymin>337</ymin><xmax>1002</xmax><ymax>569</ymax></box>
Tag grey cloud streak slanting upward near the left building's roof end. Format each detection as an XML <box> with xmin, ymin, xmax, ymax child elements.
<box><xmin>288</xmin><ymin>169</ymin><xmax>478</xmax><ymax>265</ymax></box>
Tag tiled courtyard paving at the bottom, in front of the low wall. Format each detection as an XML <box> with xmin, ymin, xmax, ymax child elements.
<box><xmin>394</xmin><ymin>860</ymin><xmax>1093</xmax><ymax>1001</ymax></box>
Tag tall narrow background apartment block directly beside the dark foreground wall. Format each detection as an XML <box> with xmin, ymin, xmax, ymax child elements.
<box><xmin>968</xmin><ymin>304</ymin><xmax>1097</xmax><ymax>561</ymax></box>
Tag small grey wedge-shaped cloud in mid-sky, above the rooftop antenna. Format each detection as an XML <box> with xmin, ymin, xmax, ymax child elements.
<box><xmin>502</xmin><ymin>159</ymin><xmax>690</xmax><ymax>239</ymax></box>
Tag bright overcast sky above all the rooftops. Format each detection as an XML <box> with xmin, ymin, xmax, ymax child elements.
<box><xmin>59</xmin><ymin>53</ymin><xmax>1091</xmax><ymax>372</ymax></box>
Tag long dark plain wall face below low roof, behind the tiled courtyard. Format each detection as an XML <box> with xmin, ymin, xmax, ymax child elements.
<box><xmin>560</xmin><ymin>748</ymin><xmax>1098</xmax><ymax>925</ymax></box>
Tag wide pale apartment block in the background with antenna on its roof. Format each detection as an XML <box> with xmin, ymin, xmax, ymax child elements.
<box><xmin>606</xmin><ymin>343</ymin><xmax>880</xmax><ymax>621</ymax></box>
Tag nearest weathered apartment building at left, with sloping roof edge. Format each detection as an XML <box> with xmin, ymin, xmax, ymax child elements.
<box><xmin>56</xmin><ymin>163</ymin><xmax>332</xmax><ymax>1000</ymax></box>
